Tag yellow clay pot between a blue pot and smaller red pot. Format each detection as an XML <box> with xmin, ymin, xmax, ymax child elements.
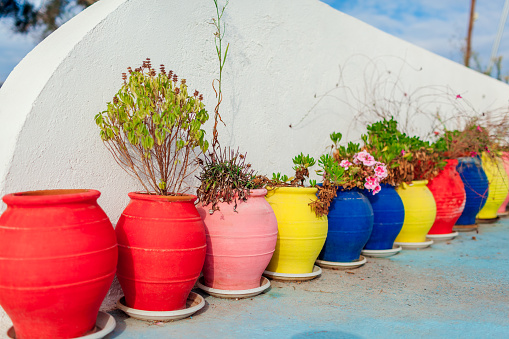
<box><xmin>396</xmin><ymin>180</ymin><xmax>437</xmax><ymax>243</ymax></box>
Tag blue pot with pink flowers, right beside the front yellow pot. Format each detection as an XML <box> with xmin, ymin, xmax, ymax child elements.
<box><xmin>316</xmin><ymin>133</ymin><xmax>387</xmax><ymax>268</ymax></box>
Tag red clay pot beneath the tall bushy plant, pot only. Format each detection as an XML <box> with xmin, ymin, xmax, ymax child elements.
<box><xmin>115</xmin><ymin>193</ymin><xmax>207</xmax><ymax>311</ymax></box>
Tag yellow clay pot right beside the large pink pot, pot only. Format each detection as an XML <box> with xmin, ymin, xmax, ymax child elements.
<box><xmin>266</xmin><ymin>187</ymin><xmax>327</xmax><ymax>274</ymax></box>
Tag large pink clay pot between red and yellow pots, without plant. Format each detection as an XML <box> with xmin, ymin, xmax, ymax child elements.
<box><xmin>198</xmin><ymin>189</ymin><xmax>277</xmax><ymax>290</ymax></box>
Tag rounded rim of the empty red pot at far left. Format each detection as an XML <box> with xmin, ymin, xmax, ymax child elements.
<box><xmin>2</xmin><ymin>189</ymin><xmax>101</xmax><ymax>205</ymax></box>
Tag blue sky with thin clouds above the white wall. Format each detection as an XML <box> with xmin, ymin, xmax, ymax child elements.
<box><xmin>0</xmin><ymin>0</ymin><xmax>509</xmax><ymax>82</ymax></box>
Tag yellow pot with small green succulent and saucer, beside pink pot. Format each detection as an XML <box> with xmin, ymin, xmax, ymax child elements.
<box><xmin>265</xmin><ymin>153</ymin><xmax>327</xmax><ymax>280</ymax></box>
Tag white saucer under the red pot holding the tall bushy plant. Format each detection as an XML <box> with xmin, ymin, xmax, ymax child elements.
<box><xmin>117</xmin><ymin>292</ymin><xmax>205</xmax><ymax>321</ymax></box>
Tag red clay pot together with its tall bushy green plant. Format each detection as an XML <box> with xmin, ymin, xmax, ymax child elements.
<box><xmin>95</xmin><ymin>59</ymin><xmax>209</xmax><ymax>311</ymax></box>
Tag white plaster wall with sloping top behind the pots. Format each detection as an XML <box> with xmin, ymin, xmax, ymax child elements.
<box><xmin>0</xmin><ymin>0</ymin><xmax>509</xmax><ymax>332</ymax></box>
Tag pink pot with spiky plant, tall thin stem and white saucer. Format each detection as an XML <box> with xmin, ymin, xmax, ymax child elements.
<box><xmin>192</xmin><ymin>0</ymin><xmax>277</xmax><ymax>298</ymax></box>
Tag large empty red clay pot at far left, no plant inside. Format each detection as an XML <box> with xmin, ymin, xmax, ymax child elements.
<box><xmin>0</xmin><ymin>190</ymin><xmax>117</xmax><ymax>339</ymax></box>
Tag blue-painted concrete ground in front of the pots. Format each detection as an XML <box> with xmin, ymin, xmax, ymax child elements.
<box><xmin>107</xmin><ymin>219</ymin><xmax>509</xmax><ymax>339</ymax></box>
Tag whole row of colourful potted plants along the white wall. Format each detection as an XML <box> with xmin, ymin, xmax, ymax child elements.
<box><xmin>0</xmin><ymin>1</ymin><xmax>507</xmax><ymax>338</ymax></box>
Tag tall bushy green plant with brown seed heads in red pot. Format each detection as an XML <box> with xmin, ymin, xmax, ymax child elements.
<box><xmin>95</xmin><ymin>58</ymin><xmax>209</xmax><ymax>195</ymax></box>
